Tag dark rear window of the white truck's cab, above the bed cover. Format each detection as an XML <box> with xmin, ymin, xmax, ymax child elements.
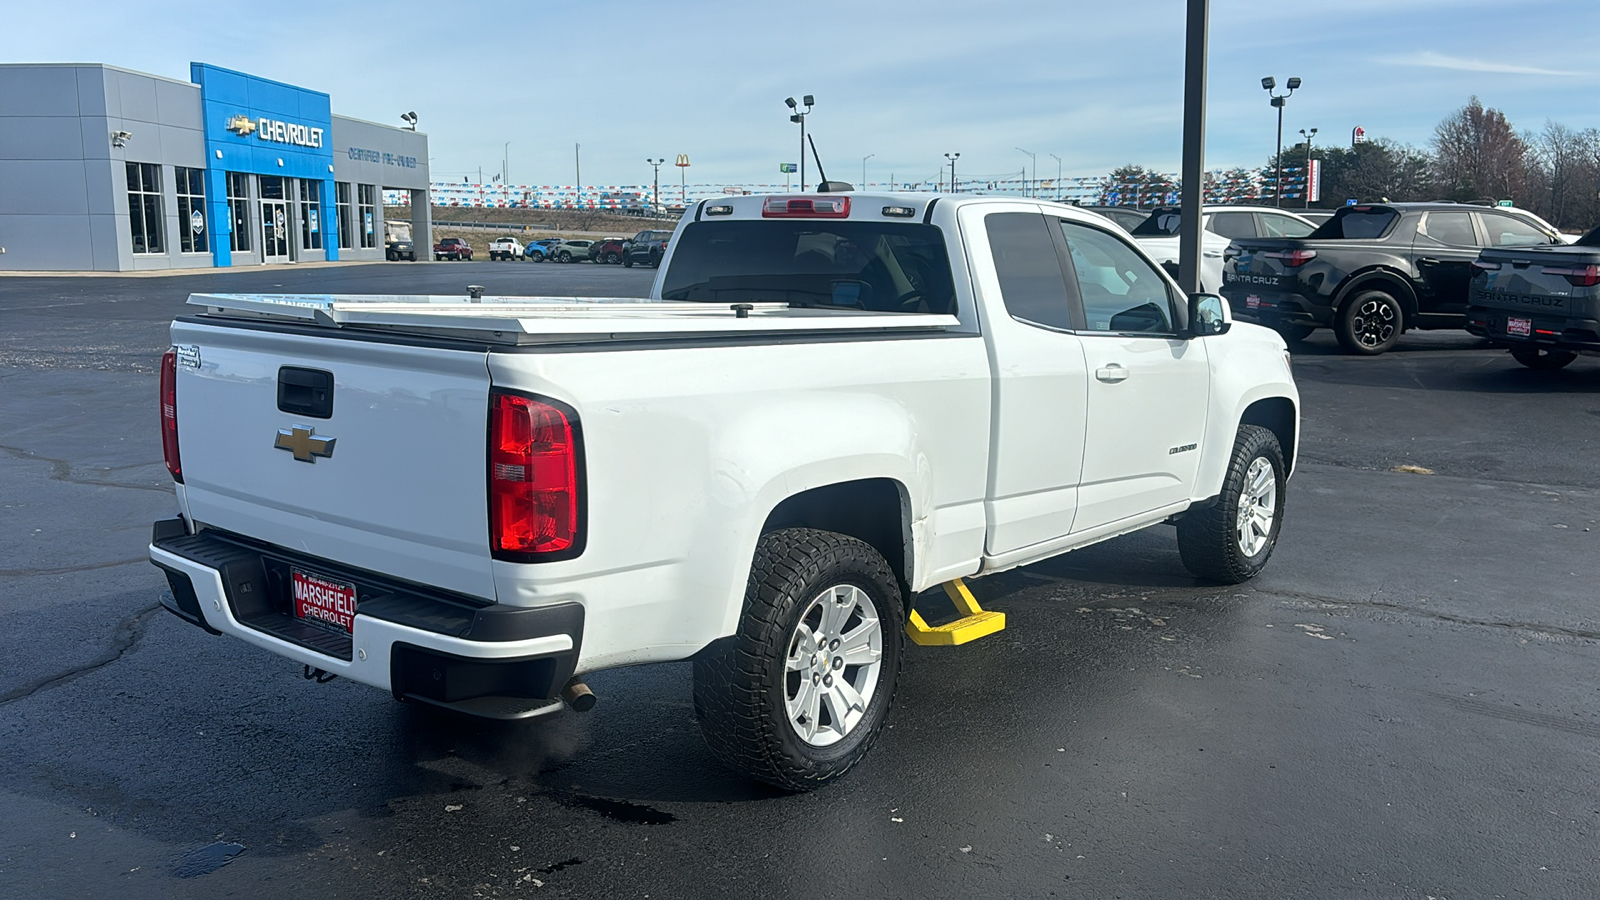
<box><xmin>661</xmin><ymin>219</ymin><xmax>955</xmax><ymax>312</ymax></box>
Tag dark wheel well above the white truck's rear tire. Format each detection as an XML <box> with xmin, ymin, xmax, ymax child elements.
<box><xmin>762</xmin><ymin>479</ymin><xmax>912</xmax><ymax>598</ymax></box>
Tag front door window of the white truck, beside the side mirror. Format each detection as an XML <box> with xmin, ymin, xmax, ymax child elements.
<box><xmin>1061</xmin><ymin>221</ymin><xmax>1173</xmax><ymax>335</ymax></box>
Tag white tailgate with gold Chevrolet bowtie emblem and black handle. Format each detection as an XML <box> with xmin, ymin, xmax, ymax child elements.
<box><xmin>173</xmin><ymin>320</ymin><xmax>494</xmax><ymax>599</ymax></box>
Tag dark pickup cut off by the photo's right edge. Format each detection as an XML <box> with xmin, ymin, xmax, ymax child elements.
<box><xmin>1467</xmin><ymin>227</ymin><xmax>1600</xmax><ymax>370</ymax></box>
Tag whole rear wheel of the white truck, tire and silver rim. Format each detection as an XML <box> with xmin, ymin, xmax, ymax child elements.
<box><xmin>694</xmin><ymin>528</ymin><xmax>906</xmax><ymax>791</ymax></box>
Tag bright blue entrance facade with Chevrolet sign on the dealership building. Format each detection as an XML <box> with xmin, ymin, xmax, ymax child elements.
<box><xmin>189</xmin><ymin>62</ymin><xmax>339</xmax><ymax>266</ymax></box>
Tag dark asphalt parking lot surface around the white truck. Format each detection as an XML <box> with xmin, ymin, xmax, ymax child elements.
<box><xmin>0</xmin><ymin>263</ymin><xmax>1600</xmax><ymax>900</ymax></box>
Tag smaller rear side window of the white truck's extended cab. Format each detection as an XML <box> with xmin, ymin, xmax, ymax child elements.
<box><xmin>984</xmin><ymin>213</ymin><xmax>1074</xmax><ymax>330</ymax></box>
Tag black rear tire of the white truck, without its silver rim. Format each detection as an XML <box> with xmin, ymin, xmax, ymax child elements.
<box><xmin>694</xmin><ymin>528</ymin><xmax>906</xmax><ymax>791</ymax></box>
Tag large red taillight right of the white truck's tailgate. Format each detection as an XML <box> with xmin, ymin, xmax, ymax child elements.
<box><xmin>490</xmin><ymin>391</ymin><xmax>582</xmax><ymax>562</ymax></box>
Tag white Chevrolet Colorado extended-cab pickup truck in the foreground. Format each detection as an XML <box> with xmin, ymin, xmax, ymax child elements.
<box><xmin>150</xmin><ymin>194</ymin><xmax>1299</xmax><ymax>790</ymax></box>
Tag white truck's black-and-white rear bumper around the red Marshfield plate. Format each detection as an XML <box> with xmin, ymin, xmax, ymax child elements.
<box><xmin>150</xmin><ymin>519</ymin><xmax>584</xmax><ymax>719</ymax></box>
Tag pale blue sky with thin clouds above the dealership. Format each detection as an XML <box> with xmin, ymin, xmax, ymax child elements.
<box><xmin>0</xmin><ymin>0</ymin><xmax>1600</xmax><ymax>186</ymax></box>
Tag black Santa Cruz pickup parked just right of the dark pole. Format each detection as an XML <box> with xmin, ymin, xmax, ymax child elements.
<box><xmin>1222</xmin><ymin>203</ymin><xmax>1565</xmax><ymax>356</ymax></box>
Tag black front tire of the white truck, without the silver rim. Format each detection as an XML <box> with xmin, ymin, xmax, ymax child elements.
<box><xmin>1178</xmin><ymin>424</ymin><xmax>1286</xmax><ymax>585</ymax></box>
